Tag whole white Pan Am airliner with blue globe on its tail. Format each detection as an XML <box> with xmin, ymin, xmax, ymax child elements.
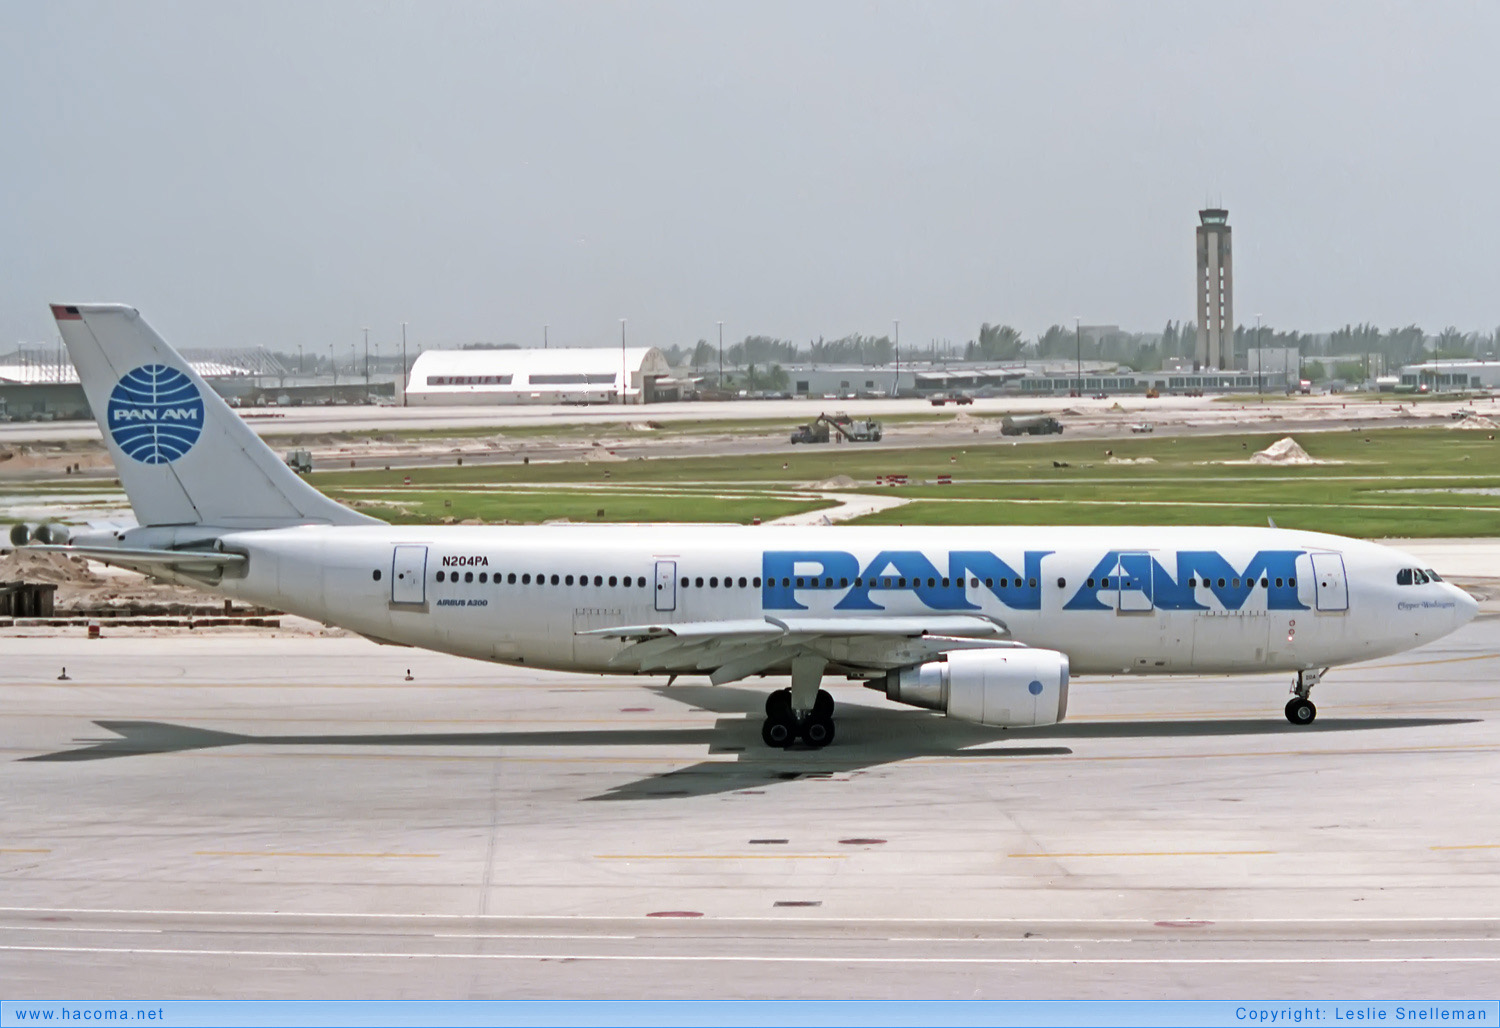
<box><xmin>20</xmin><ymin>303</ymin><xmax>1476</xmax><ymax>747</ymax></box>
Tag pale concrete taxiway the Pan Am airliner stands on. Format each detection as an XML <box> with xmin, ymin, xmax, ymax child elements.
<box><xmin>0</xmin><ymin>611</ymin><xmax>1500</xmax><ymax>999</ymax></box>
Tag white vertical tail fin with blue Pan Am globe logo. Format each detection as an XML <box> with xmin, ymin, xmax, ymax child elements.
<box><xmin>53</xmin><ymin>303</ymin><xmax>378</xmax><ymax>528</ymax></box>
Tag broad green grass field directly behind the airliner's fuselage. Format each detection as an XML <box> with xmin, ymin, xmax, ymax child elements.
<box><xmin>307</xmin><ymin>428</ymin><xmax>1500</xmax><ymax>536</ymax></box>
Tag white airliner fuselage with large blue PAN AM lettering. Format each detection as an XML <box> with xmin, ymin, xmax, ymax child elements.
<box><xmin>190</xmin><ymin>525</ymin><xmax>1475</xmax><ymax>674</ymax></box>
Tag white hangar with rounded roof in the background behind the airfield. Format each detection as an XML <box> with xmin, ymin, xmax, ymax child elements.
<box><xmin>407</xmin><ymin>347</ymin><xmax>678</xmax><ymax>407</ymax></box>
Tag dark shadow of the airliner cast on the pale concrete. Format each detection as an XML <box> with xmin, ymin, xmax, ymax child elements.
<box><xmin>21</xmin><ymin>686</ymin><xmax>1475</xmax><ymax>800</ymax></box>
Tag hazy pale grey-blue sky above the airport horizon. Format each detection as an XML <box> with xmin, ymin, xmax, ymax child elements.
<box><xmin>0</xmin><ymin>0</ymin><xmax>1500</xmax><ymax>353</ymax></box>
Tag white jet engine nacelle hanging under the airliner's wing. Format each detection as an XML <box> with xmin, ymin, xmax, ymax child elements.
<box><xmin>885</xmin><ymin>647</ymin><xmax>1068</xmax><ymax>728</ymax></box>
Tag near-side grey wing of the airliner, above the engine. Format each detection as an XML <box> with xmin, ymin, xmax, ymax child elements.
<box><xmin>579</xmin><ymin>614</ymin><xmax>1020</xmax><ymax>684</ymax></box>
